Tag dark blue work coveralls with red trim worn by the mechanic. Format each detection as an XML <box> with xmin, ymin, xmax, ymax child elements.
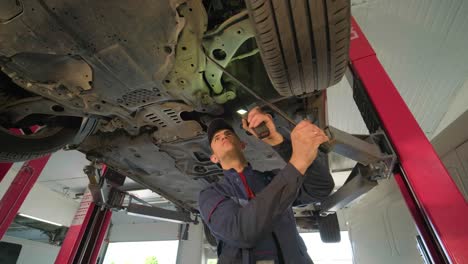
<box><xmin>199</xmin><ymin>137</ymin><xmax>334</xmax><ymax>264</ymax></box>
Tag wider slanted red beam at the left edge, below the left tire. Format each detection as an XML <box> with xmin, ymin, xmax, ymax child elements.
<box><xmin>0</xmin><ymin>155</ymin><xmax>50</xmax><ymax>239</ymax></box>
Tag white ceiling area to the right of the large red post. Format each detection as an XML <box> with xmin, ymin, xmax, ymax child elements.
<box><xmin>352</xmin><ymin>0</ymin><xmax>468</xmax><ymax>136</ymax></box>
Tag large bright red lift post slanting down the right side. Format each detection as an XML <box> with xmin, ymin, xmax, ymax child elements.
<box><xmin>350</xmin><ymin>19</ymin><xmax>468</xmax><ymax>263</ymax></box>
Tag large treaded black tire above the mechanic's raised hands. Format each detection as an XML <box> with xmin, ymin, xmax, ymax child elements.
<box><xmin>246</xmin><ymin>0</ymin><xmax>351</xmax><ymax>96</ymax></box>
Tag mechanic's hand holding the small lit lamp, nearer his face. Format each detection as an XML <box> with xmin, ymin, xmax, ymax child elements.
<box><xmin>242</xmin><ymin>106</ymin><xmax>284</xmax><ymax>146</ymax></box>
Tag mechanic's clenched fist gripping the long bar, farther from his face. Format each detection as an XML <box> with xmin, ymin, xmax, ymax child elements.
<box><xmin>289</xmin><ymin>120</ymin><xmax>329</xmax><ymax>175</ymax></box>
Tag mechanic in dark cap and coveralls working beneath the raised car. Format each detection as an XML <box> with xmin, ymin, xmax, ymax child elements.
<box><xmin>199</xmin><ymin>107</ymin><xmax>334</xmax><ymax>264</ymax></box>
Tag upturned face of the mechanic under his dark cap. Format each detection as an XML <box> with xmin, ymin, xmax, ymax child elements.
<box><xmin>211</xmin><ymin>129</ymin><xmax>245</xmax><ymax>163</ymax></box>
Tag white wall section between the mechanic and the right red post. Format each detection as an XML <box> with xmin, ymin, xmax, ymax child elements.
<box><xmin>342</xmin><ymin>179</ymin><xmax>423</xmax><ymax>264</ymax></box>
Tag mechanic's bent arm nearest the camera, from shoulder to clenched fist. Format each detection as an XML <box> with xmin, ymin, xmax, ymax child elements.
<box><xmin>199</xmin><ymin>121</ymin><xmax>328</xmax><ymax>247</ymax></box>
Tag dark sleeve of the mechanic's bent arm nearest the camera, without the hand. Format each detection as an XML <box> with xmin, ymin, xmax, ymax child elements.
<box><xmin>199</xmin><ymin>163</ymin><xmax>303</xmax><ymax>248</ymax></box>
